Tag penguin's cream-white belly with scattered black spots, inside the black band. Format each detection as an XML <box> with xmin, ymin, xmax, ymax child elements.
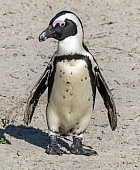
<box><xmin>47</xmin><ymin>59</ymin><xmax>94</xmax><ymax>134</ymax></box>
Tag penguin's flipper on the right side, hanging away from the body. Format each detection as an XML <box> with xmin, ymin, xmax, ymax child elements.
<box><xmin>95</xmin><ymin>67</ymin><xmax>117</xmax><ymax>131</ymax></box>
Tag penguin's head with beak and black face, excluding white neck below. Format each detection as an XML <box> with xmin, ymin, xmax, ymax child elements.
<box><xmin>39</xmin><ymin>11</ymin><xmax>83</xmax><ymax>41</ymax></box>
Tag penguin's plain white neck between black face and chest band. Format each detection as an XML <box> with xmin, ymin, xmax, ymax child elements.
<box><xmin>57</xmin><ymin>33</ymin><xmax>83</xmax><ymax>56</ymax></box>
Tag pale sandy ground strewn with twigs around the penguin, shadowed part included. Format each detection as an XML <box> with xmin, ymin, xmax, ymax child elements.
<box><xmin>0</xmin><ymin>0</ymin><xmax>140</xmax><ymax>170</ymax></box>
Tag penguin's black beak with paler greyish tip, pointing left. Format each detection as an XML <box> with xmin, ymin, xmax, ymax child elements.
<box><xmin>39</xmin><ymin>25</ymin><xmax>56</xmax><ymax>42</ymax></box>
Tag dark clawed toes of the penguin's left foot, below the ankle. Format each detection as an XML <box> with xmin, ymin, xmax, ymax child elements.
<box><xmin>46</xmin><ymin>145</ymin><xmax>64</xmax><ymax>156</ymax></box>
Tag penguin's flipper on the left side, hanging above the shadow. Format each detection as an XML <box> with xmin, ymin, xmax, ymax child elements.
<box><xmin>24</xmin><ymin>66</ymin><xmax>50</xmax><ymax>125</ymax></box>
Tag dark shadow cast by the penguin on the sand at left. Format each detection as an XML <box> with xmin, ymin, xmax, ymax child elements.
<box><xmin>0</xmin><ymin>125</ymin><xmax>70</xmax><ymax>151</ymax></box>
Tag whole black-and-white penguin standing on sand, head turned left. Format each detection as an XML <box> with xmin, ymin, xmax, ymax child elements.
<box><xmin>24</xmin><ymin>11</ymin><xmax>117</xmax><ymax>156</ymax></box>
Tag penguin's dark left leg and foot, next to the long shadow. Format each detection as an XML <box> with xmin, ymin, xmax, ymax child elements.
<box><xmin>46</xmin><ymin>135</ymin><xmax>64</xmax><ymax>155</ymax></box>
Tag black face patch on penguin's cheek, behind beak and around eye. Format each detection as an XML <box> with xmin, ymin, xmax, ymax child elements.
<box><xmin>51</xmin><ymin>19</ymin><xmax>77</xmax><ymax>41</ymax></box>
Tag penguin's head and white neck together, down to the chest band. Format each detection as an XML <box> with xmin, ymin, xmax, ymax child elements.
<box><xmin>39</xmin><ymin>11</ymin><xmax>84</xmax><ymax>54</ymax></box>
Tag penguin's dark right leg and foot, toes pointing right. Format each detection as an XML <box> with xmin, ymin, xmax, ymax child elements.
<box><xmin>70</xmin><ymin>136</ymin><xmax>98</xmax><ymax>156</ymax></box>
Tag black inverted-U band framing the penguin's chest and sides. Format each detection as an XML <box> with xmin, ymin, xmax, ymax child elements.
<box><xmin>48</xmin><ymin>54</ymin><xmax>96</xmax><ymax>107</ymax></box>
